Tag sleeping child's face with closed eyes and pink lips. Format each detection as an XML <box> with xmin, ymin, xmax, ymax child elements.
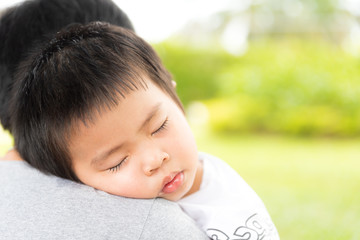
<box><xmin>70</xmin><ymin>77</ymin><xmax>199</xmax><ymax>201</ymax></box>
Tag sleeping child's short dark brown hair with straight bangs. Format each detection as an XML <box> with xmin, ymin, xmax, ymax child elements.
<box><xmin>10</xmin><ymin>22</ymin><xmax>182</xmax><ymax>181</ymax></box>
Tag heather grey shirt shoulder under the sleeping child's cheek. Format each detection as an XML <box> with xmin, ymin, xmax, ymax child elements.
<box><xmin>0</xmin><ymin>160</ymin><xmax>208</xmax><ymax>239</ymax></box>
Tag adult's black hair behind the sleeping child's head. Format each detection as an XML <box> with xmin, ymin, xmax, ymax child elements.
<box><xmin>0</xmin><ymin>0</ymin><xmax>134</xmax><ymax>130</ymax></box>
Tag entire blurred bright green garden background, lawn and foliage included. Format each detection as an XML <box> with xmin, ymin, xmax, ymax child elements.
<box><xmin>0</xmin><ymin>0</ymin><xmax>360</xmax><ymax>240</ymax></box>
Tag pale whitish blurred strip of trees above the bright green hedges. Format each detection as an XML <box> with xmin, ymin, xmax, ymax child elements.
<box><xmin>173</xmin><ymin>0</ymin><xmax>360</xmax><ymax>55</ymax></box>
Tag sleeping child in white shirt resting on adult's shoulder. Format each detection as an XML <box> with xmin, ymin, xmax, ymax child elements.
<box><xmin>10</xmin><ymin>23</ymin><xmax>279</xmax><ymax>239</ymax></box>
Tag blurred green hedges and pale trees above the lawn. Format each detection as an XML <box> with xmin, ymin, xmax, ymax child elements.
<box><xmin>158</xmin><ymin>0</ymin><xmax>360</xmax><ymax>137</ymax></box>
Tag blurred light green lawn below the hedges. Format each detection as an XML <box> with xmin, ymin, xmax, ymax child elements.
<box><xmin>198</xmin><ymin>131</ymin><xmax>360</xmax><ymax>240</ymax></box>
